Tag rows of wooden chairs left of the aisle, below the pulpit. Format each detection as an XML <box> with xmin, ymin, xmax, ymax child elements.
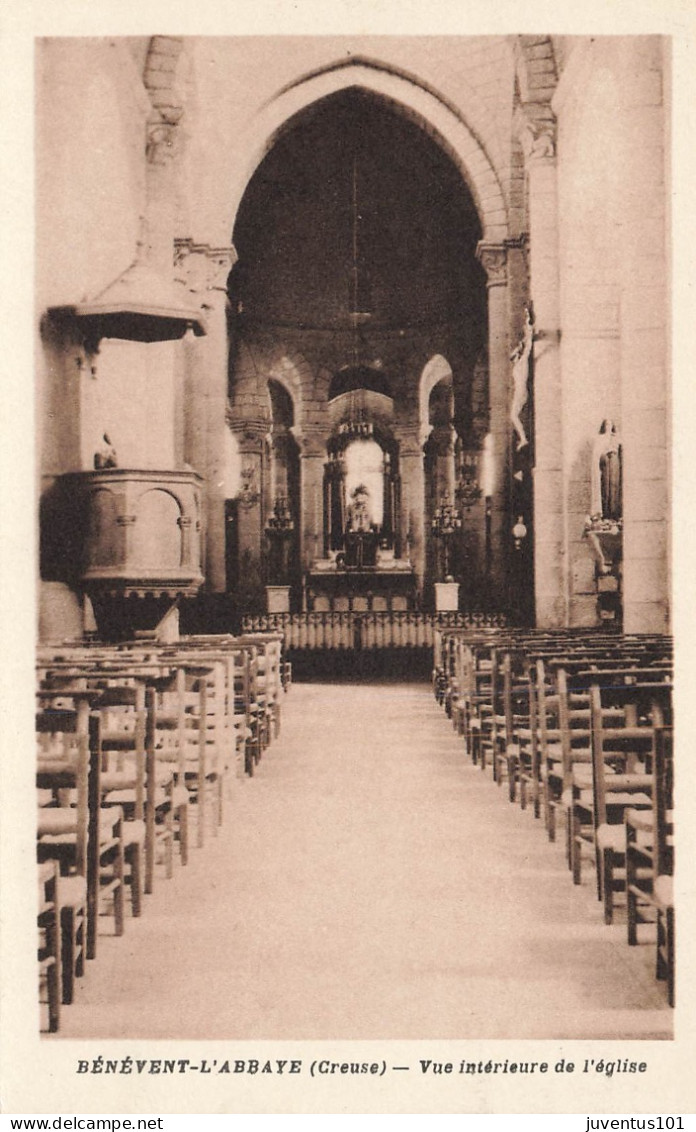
<box><xmin>36</xmin><ymin>634</ymin><xmax>291</xmax><ymax>1030</ymax></box>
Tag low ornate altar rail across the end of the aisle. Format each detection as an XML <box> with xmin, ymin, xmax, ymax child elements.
<box><xmin>242</xmin><ymin>609</ymin><xmax>507</xmax><ymax>651</ymax></box>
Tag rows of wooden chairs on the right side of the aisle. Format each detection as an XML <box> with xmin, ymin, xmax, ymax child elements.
<box><xmin>433</xmin><ymin>629</ymin><xmax>674</xmax><ymax>1004</ymax></box>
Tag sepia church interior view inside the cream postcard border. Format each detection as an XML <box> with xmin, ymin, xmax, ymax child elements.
<box><xmin>35</xmin><ymin>35</ymin><xmax>674</xmax><ymax>1039</ymax></box>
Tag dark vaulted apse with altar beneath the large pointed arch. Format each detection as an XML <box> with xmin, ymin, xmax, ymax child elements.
<box><xmin>229</xmin><ymin>87</ymin><xmax>488</xmax><ymax>608</ymax></box>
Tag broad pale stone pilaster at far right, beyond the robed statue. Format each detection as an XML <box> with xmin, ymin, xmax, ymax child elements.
<box><xmin>618</xmin><ymin>36</ymin><xmax>671</xmax><ymax>633</ymax></box>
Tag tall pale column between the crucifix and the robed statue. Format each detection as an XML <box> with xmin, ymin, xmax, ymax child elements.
<box><xmin>516</xmin><ymin>104</ymin><xmax>568</xmax><ymax>628</ymax></box>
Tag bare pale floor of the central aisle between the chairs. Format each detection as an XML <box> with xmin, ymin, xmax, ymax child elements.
<box><xmin>61</xmin><ymin>684</ymin><xmax>671</xmax><ymax>1040</ymax></box>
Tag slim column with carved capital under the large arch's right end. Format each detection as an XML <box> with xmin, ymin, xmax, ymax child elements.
<box><xmin>476</xmin><ymin>240</ymin><xmax>510</xmax><ymax>606</ymax></box>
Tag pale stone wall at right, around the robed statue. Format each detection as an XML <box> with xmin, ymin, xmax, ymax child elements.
<box><xmin>553</xmin><ymin>37</ymin><xmax>670</xmax><ymax>631</ymax></box>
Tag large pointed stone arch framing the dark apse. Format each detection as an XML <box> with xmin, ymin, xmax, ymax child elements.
<box><xmin>230</xmin><ymin>60</ymin><xmax>508</xmax><ymax>241</ymax></box>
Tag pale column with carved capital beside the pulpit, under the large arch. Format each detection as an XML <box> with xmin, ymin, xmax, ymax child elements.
<box><xmin>174</xmin><ymin>239</ymin><xmax>237</xmax><ymax>593</ymax></box>
